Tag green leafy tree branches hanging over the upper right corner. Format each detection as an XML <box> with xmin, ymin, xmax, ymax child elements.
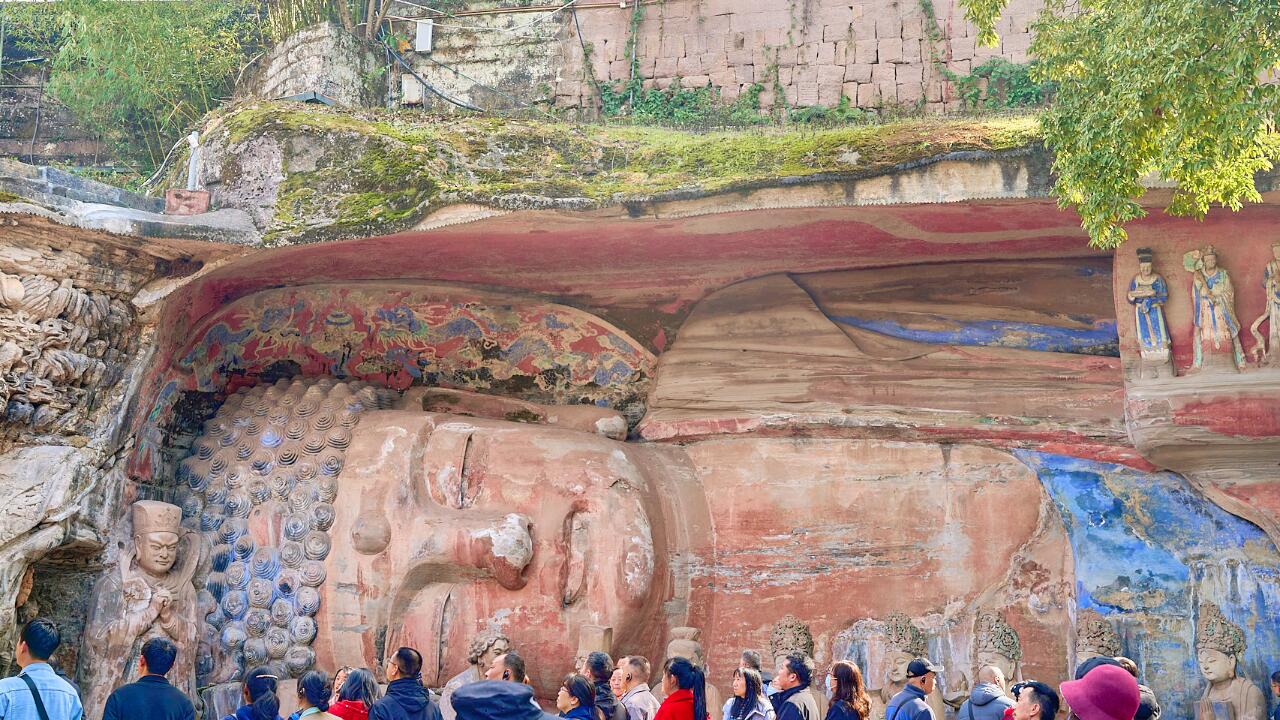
<box><xmin>961</xmin><ymin>0</ymin><xmax>1280</xmax><ymax>247</ymax></box>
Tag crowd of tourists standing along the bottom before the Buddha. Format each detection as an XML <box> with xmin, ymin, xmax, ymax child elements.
<box><xmin>0</xmin><ymin>619</ymin><xmax>1280</xmax><ymax>720</ymax></box>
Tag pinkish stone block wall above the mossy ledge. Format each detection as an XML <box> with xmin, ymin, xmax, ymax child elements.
<box><xmin>402</xmin><ymin>0</ymin><xmax>1043</xmax><ymax>111</ymax></box>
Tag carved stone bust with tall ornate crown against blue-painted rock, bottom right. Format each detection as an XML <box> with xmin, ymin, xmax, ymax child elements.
<box><xmin>1196</xmin><ymin>602</ymin><xmax>1267</xmax><ymax>720</ymax></box>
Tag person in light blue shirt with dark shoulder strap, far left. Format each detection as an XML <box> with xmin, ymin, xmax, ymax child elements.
<box><xmin>0</xmin><ymin>618</ymin><xmax>84</xmax><ymax>720</ymax></box>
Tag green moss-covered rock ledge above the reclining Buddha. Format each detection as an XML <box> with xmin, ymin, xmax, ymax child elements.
<box><xmin>199</xmin><ymin>102</ymin><xmax>1041</xmax><ymax>243</ymax></box>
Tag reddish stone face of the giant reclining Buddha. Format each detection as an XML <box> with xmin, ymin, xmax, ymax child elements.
<box><xmin>317</xmin><ymin>411</ymin><xmax>667</xmax><ymax>696</ymax></box>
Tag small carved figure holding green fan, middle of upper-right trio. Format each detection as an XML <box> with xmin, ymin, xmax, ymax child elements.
<box><xmin>1183</xmin><ymin>245</ymin><xmax>1244</xmax><ymax>370</ymax></box>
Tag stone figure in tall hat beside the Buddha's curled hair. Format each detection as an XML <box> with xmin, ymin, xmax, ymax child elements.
<box><xmin>81</xmin><ymin>500</ymin><xmax>200</xmax><ymax>717</ymax></box>
